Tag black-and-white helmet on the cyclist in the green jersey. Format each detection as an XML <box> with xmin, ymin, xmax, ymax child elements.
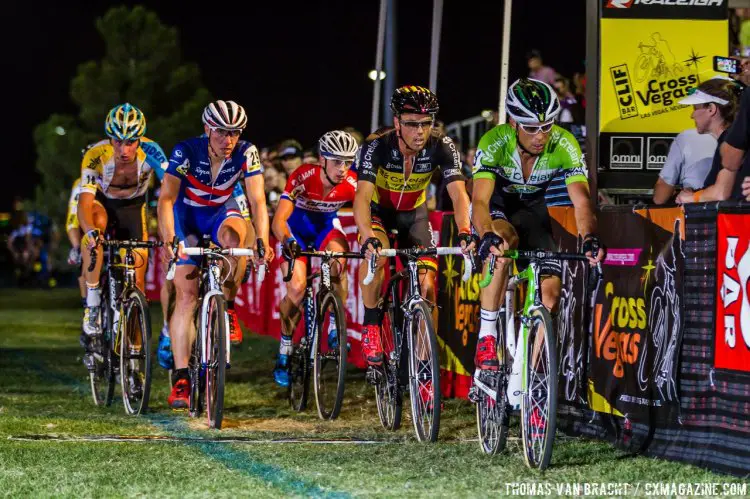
<box><xmin>505</xmin><ymin>78</ymin><xmax>562</xmax><ymax>125</ymax></box>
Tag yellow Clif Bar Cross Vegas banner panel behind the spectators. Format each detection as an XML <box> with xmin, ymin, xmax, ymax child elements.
<box><xmin>599</xmin><ymin>0</ymin><xmax>728</xmax><ymax>171</ymax></box>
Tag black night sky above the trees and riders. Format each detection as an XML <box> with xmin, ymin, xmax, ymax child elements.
<box><xmin>0</xmin><ymin>0</ymin><xmax>585</xmax><ymax>211</ymax></box>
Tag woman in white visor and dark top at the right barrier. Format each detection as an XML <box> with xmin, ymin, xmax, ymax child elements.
<box><xmin>677</xmin><ymin>78</ymin><xmax>750</xmax><ymax>204</ymax></box>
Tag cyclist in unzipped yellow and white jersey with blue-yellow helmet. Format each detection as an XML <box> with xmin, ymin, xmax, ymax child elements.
<box><xmin>78</xmin><ymin>103</ymin><xmax>167</xmax><ymax>358</ymax></box>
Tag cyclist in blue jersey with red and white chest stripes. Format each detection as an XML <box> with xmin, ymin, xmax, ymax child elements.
<box><xmin>158</xmin><ymin>100</ymin><xmax>273</xmax><ymax>408</ymax></box>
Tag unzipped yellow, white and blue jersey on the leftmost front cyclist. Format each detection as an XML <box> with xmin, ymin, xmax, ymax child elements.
<box><xmin>81</xmin><ymin>137</ymin><xmax>167</xmax><ymax>199</ymax></box>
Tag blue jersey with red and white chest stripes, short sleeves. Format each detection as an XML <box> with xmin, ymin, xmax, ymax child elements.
<box><xmin>167</xmin><ymin>136</ymin><xmax>263</xmax><ymax>208</ymax></box>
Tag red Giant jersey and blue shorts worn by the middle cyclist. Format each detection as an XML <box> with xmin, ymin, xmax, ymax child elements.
<box><xmin>281</xmin><ymin>164</ymin><xmax>357</xmax><ymax>254</ymax></box>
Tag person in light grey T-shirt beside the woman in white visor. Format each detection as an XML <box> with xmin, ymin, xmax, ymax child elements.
<box><xmin>654</xmin><ymin>131</ymin><xmax>717</xmax><ymax>204</ymax></box>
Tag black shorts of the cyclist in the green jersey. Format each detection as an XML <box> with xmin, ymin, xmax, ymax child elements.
<box><xmin>476</xmin><ymin>197</ymin><xmax>562</xmax><ymax>278</ymax></box>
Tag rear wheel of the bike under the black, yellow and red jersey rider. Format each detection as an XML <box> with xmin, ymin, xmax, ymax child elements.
<box><xmin>375</xmin><ymin>281</ymin><xmax>404</xmax><ymax>431</ymax></box>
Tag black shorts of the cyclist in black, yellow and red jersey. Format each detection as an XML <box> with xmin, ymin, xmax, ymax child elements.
<box><xmin>372</xmin><ymin>203</ymin><xmax>437</xmax><ymax>272</ymax></box>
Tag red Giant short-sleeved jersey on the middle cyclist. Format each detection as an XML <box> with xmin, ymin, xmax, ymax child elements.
<box><xmin>281</xmin><ymin>164</ymin><xmax>357</xmax><ymax>214</ymax></box>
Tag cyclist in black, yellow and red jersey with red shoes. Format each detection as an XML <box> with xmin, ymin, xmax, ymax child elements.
<box><xmin>354</xmin><ymin>85</ymin><xmax>473</xmax><ymax>365</ymax></box>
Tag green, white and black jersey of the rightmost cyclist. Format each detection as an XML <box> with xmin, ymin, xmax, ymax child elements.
<box><xmin>473</xmin><ymin>124</ymin><xmax>587</xmax><ymax>211</ymax></box>
